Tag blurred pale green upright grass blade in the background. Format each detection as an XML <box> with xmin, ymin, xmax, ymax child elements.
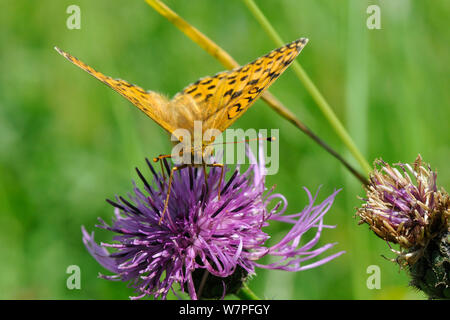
<box><xmin>344</xmin><ymin>0</ymin><xmax>375</xmax><ymax>299</ymax></box>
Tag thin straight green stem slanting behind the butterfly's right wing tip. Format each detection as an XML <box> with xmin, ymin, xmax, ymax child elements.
<box><xmin>242</xmin><ymin>0</ymin><xmax>372</xmax><ymax>174</ymax></box>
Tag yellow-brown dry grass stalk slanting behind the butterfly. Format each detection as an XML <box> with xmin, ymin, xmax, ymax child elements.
<box><xmin>146</xmin><ymin>0</ymin><xmax>367</xmax><ymax>184</ymax></box>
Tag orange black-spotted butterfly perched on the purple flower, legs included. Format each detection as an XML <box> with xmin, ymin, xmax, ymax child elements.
<box><xmin>55</xmin><ymin>38</ymin><xmax>308</xmax><ymax>222</ymax></box>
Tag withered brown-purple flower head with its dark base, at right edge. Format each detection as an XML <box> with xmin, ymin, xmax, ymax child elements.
<box><xmin>357</xmin><ymin>155</ymin><xmax>450</xmax><ymax>297</ymax></box>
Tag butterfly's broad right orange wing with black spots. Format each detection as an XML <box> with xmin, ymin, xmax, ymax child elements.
<box><xmin>175</xmin><ymin>38</ymin><xmax>308</xmax><ymax>131</ymax></box>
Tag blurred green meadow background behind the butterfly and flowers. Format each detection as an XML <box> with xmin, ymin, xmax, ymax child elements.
<box><xmin>0</xmin><ymin>0</ymin><xmax>450</xmax><ymax>299</ymax></box>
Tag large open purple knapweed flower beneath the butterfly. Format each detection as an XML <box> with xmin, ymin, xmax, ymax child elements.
<box><xmin>82</xmin><ymin>151</ymin><xmax>344</xmax><ymax>299</ymax></box>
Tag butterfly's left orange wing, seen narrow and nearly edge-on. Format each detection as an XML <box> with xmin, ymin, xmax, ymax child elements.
<box><xmin>55</xmin><ymin>47</ymin><xmax>176</xmax><ymax>138</ymax></box>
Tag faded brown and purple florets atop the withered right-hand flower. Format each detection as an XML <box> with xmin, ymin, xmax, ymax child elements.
<box><xmin>357</xmin><ymin>155</ymin><xmax>450</xmax><ymax>249</ymax></box>
